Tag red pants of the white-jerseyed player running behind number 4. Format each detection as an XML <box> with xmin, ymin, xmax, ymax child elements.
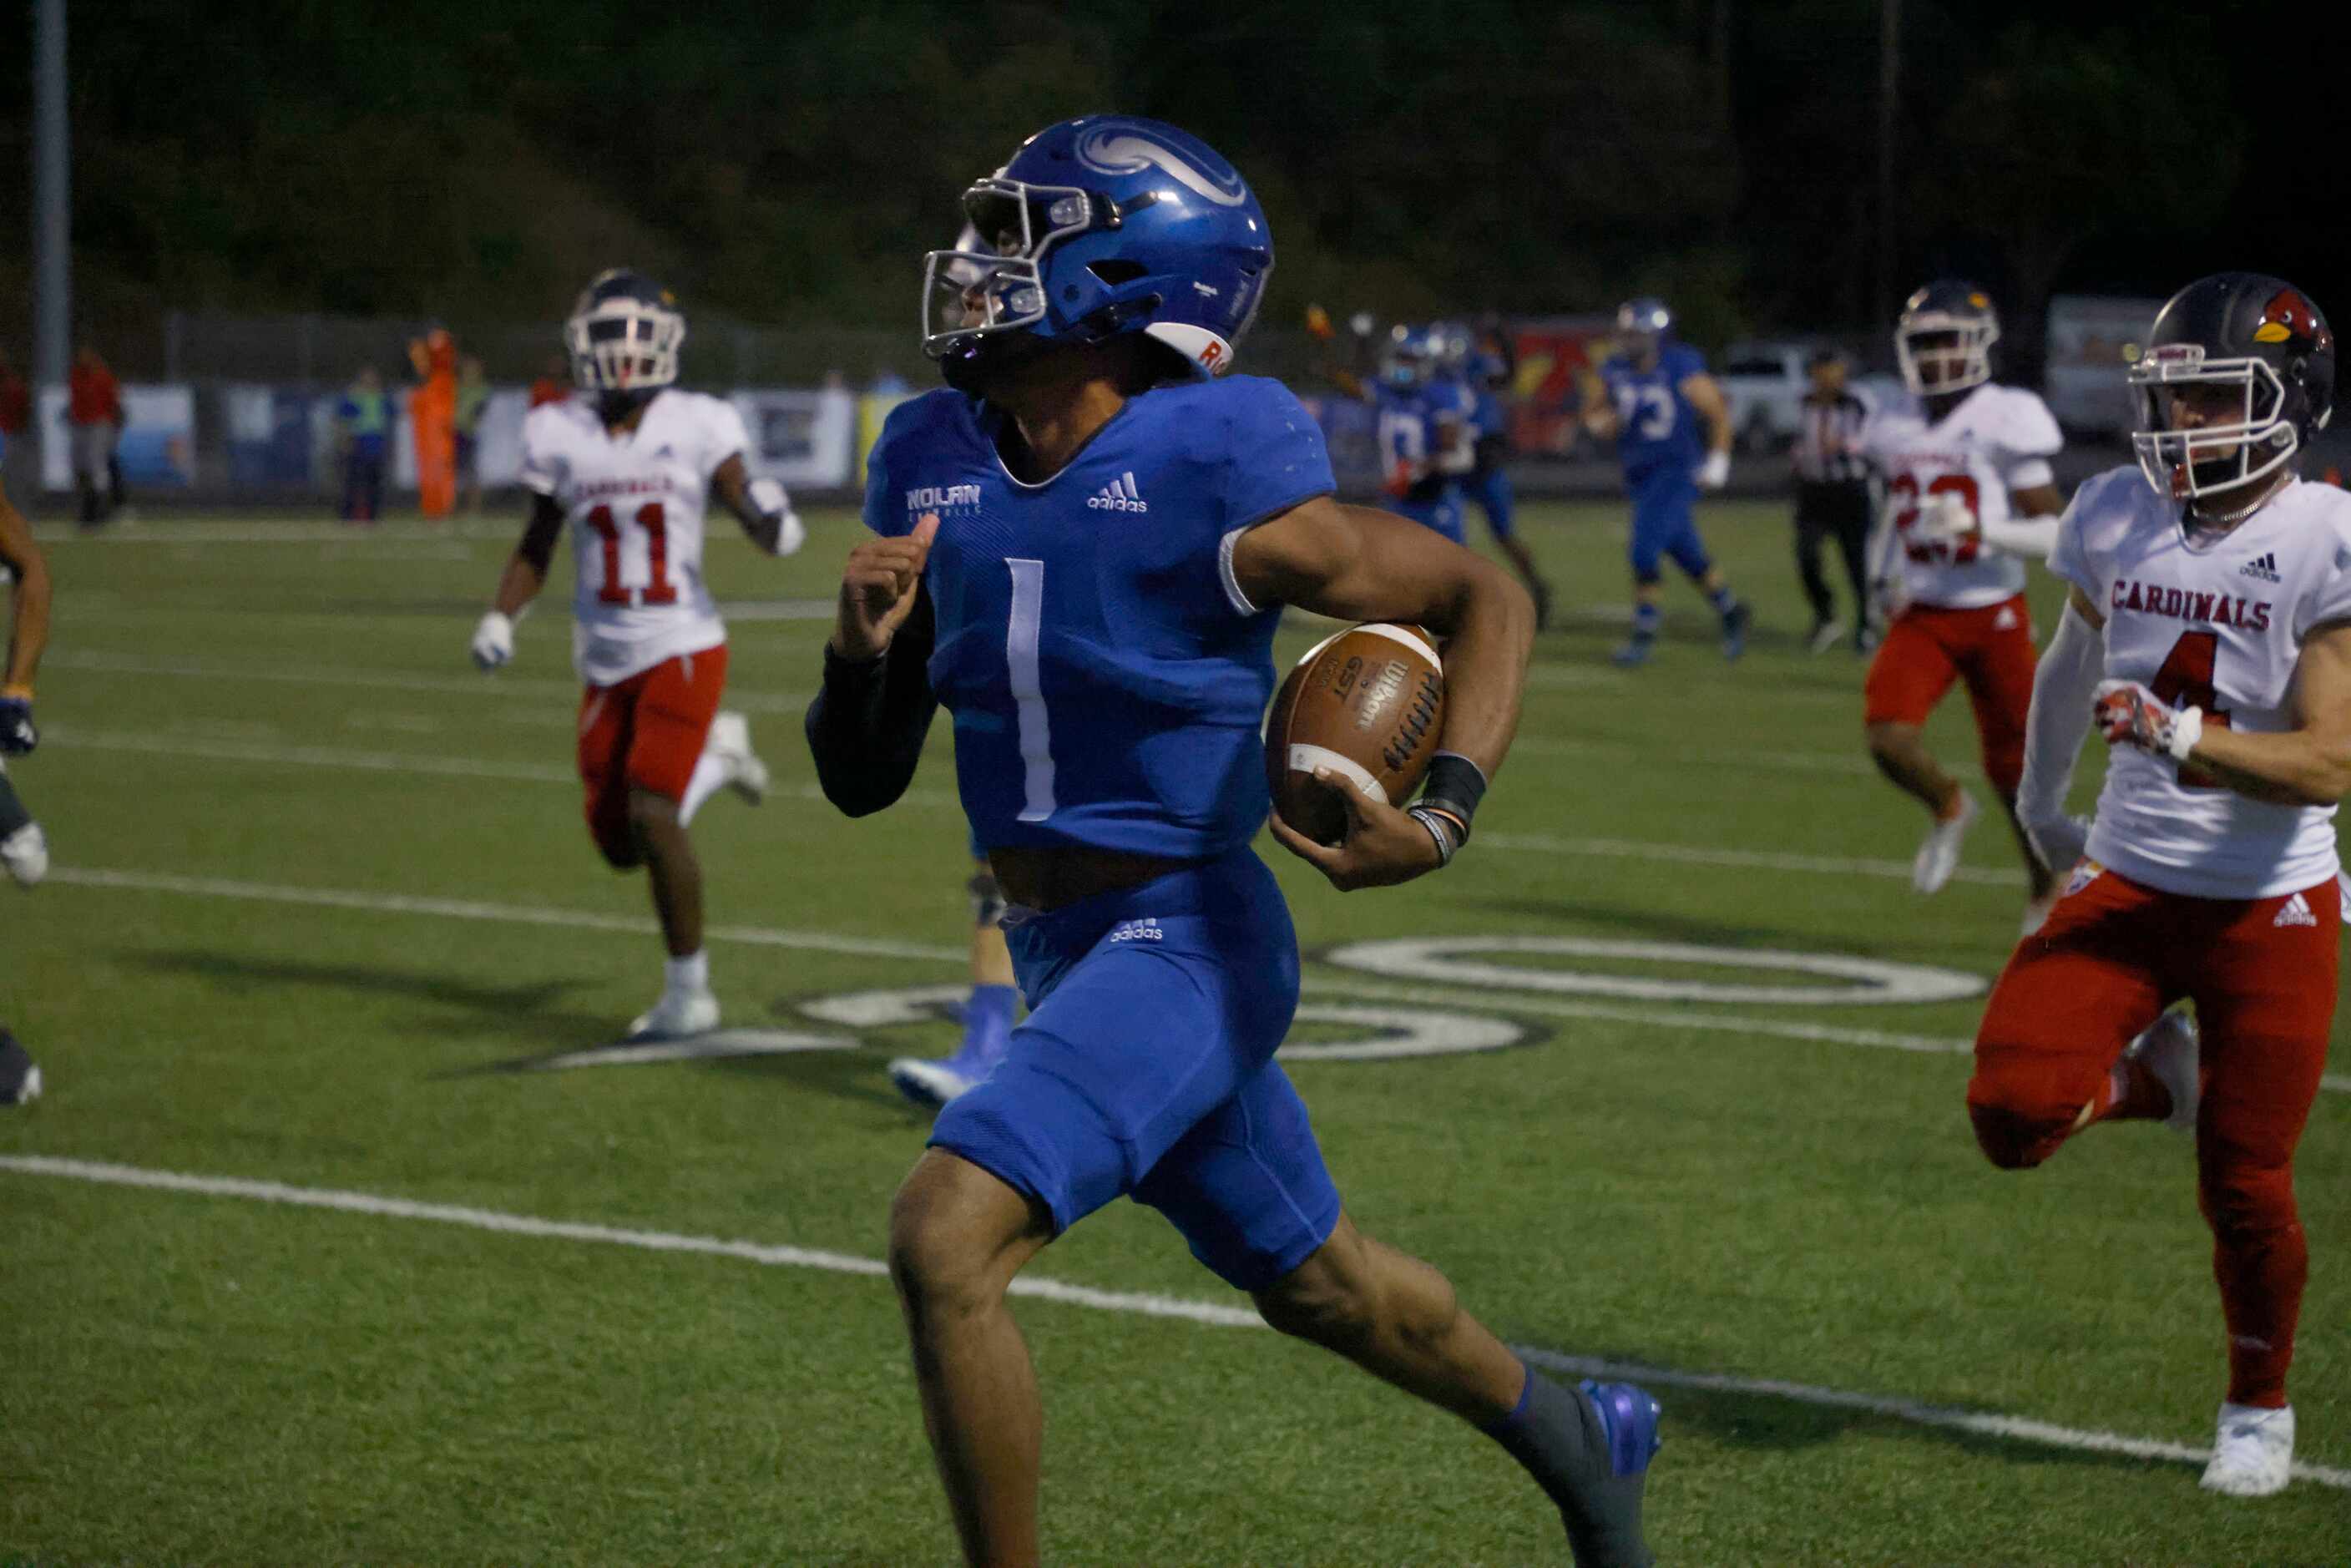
<box><xmin>1862</xmin><ymin>594</ymin><xmax>2036</xmax><ymax>799</ymax></box>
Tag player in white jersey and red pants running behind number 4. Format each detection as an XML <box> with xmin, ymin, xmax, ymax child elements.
<box><xmin>1862</xmin><ymin>282</ymin><xmax>2064</xmax><ymax>931</ymax></box>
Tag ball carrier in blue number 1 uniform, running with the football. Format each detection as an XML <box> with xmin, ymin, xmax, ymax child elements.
<box><xmin>809</xmin><ymin>118</ymin><xmax>1657</xmax><ymax>1565</ymax></box>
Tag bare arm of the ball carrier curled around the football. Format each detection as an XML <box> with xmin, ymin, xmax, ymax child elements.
<box><xmin>1232</xmin><ymin>496</ymin><xmax>1535</xmax><ymax>891</ymax></box>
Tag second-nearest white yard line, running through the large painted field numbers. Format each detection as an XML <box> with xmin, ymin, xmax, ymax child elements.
<box><xmin>49</xmin><ymin>865</ymin><xmax>2351</xmax><ymax>1093</ymax></box>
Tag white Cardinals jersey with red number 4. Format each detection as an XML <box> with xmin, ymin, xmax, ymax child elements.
<box><xmin>2050</xmin><ymin>468</ymin><xmax>2351</xmax><ymax>898</ymax></box>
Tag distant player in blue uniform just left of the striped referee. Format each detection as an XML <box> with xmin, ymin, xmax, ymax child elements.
<box><xmin>1585</xmin><ymin>299</ymin><xmax>1749</xmax><ymax>665</ymax></box>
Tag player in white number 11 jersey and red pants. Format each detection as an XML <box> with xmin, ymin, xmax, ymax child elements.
<box><xmin>473</xmin><ymin>271</ymin><xmax>804</xmax><ymax>1039</ymax></box>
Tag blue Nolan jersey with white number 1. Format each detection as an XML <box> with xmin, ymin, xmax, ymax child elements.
<box><xmin>865</xmin><ymin>376</ymin><xmax>1335</xmax><ymax>858</ymax></box>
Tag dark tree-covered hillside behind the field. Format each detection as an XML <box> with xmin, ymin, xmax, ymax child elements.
<box><xmin>0</xmin><ymin>0</ymin><xmax>2313</xmax><ymax>376</ymax></box>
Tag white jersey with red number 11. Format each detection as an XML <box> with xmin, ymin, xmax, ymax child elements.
<box><xmin>522</xmin><ymin>388</ymin><xmax>750</xmax><ymax>686</ymax></box>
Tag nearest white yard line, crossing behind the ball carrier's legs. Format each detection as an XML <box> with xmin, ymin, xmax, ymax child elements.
<box><xmin>0</xmin><ymin>1154</ymin><xmax>2351</xmax><ymax>1490</ymax></box>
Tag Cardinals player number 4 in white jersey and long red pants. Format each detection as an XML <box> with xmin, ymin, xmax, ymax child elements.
<box><xmin>1968</xmin><ymin>273</ymin><xmax>2351</xmax><ymax>1498</ymax></box>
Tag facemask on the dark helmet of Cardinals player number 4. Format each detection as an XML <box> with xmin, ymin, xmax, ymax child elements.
<box><xmin>2130</xmin><ymin>343</ymin><xmax>2302</xmax><ymax>512</ymax></box>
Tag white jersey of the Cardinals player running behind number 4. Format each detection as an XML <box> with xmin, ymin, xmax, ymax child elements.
<box><xmin>1862</xmin><ymin>383</ymin><xmax>2064</xmax><ymax>609</ymax></box>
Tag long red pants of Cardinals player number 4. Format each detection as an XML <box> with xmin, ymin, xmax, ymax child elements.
<box><xmin>1968</xmin><ymin>873</ymin><xmax>2342</xmax><ymax>1406</ymax></box>
